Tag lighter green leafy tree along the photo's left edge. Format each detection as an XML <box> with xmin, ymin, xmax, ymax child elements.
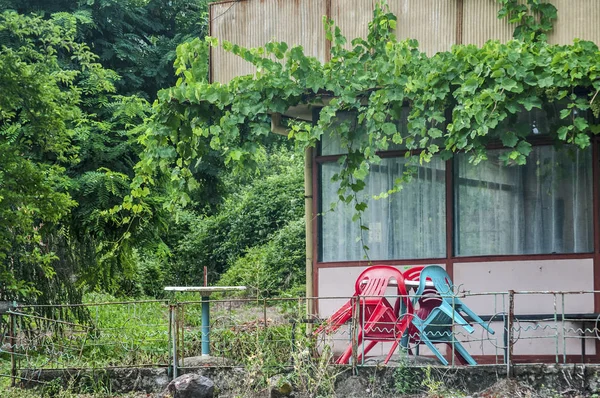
<box><xmin>0</xmin><ymin>12</ymin><xmax>116</xmax><ymax>300</ymax></box>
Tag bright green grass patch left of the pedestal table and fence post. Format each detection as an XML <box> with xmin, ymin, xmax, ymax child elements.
<box><xmin>2</xmin><ymin>294</ymin><xmax>168</xmax><ymax>374</ymax></box>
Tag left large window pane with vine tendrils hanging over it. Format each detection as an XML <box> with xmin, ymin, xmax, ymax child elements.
<box><xmin>320</xmin><ymin>158</ymin><xmax>446</xmax><ymax>262</ymax></box>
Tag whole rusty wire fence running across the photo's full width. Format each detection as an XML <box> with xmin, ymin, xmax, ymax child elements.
<box><xmin>0</xmin><ymin>291</ymin><xmax>600</xmax><ymax>383</ymax></box>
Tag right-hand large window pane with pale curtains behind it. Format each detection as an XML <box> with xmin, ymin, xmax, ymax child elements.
<box><xmin>455</xmin><ymin>146</ymin><xmax>593</xmax><ymax>256</ymax></box>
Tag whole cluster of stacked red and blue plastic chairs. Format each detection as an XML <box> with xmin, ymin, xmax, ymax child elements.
<box><xmin>315</xmin><ymin>265</ymin><xmax>494</xmax><ymax>365</ymax></box>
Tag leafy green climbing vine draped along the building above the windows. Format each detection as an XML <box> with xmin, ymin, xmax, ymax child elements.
<box><xmin>125</xmin><ymin>0</ymin><xmax>600</xmax><ymax>230</ymax></box>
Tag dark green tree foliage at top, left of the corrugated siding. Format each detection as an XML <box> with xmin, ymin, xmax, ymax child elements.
<box><xmin>0</xmin><ymin>0</ymin><xmax>208</xmax><ymax>100</ymax></box>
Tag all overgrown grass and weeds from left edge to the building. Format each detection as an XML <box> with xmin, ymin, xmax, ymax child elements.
<box><xmin>0</xmin><ymin>293</ymin><xmax>330</xmax><ymax>398</ymax></box>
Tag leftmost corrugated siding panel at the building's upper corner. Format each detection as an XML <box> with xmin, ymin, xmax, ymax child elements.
<box><xmin>210</xmin><ymin>0</ymin><xmax>326</xmax><ymax>83</ymax></box>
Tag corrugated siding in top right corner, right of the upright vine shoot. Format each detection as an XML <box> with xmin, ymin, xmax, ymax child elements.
<box><xmin>548</xmin><ymin>0</ymin><xmax>600</xmax><ymax>45</ymax></box>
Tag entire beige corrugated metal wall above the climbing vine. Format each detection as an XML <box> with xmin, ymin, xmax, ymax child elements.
<box><xmin>210</xmin><ymin>0</ymin><xmax>600</xmax><ymax>82</ymax></box>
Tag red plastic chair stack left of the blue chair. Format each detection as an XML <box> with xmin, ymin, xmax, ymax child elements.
<box><xmin>316</xmin><ymin>265</ymin><xmax>412</xmax><ymax>364</ymax></box>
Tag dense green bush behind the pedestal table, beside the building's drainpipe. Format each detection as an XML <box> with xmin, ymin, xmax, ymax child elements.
<box><xmin>168</xmin><ymin>149</ymin><xmax>304</xmax><ymax>287</ymax></box>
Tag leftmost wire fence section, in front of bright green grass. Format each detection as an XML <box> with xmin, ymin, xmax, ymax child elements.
<box><xmin>0</xmin><ymin>300</ymin><xmax>170</xmax><ymax>384</ymax></box>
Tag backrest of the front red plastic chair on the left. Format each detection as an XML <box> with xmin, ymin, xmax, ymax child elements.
<box><xmin>354</xmin><ymin>265</ymin><xmax>412</xmax><ymax>313</ymax></box>
